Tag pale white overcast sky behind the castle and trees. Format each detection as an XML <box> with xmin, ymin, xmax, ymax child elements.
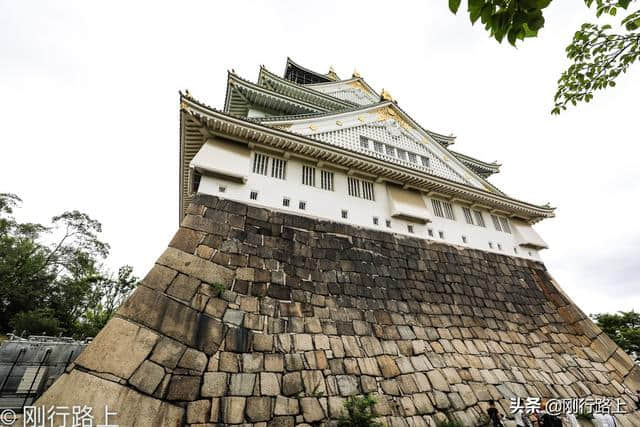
<box><xmin>0</xmin><ymin>0</ymin><xmax>640</xmax><ymax>313</ymax></box>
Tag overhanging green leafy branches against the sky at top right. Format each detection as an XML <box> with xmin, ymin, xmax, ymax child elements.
<box><xmin>449</xmin><ymin>0</ymin><xmax>640</xmax><ymax>114</ymax></box>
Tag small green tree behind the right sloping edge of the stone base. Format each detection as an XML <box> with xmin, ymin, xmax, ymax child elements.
<box><xmin>592</xmin><ymin>310</ymin><xmax>640</xmax><ymax>358</ymax></box>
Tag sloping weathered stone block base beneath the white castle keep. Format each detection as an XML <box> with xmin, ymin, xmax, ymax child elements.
<box><xmin>38</xmin><ymin>195</ymin><xmax>640</xmax><ymax>426</ymax></box>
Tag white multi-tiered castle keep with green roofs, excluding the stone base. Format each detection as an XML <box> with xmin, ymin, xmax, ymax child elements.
<box><xmin>180</xmin><ymin>59</ymin><xmax>554</xmax><ymax>259</ymax></box>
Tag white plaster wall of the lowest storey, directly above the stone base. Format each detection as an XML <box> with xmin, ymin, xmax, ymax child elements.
<box><xmin>198</xmin><ymin>156</ymin><xmax>540</xmax><ymax>260</ymax></box>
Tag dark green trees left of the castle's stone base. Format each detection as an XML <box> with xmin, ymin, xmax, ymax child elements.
<box><xmin>0</xmin><ymin>193</ymin><xmax>137</xmax><ymax>337</ymax></box>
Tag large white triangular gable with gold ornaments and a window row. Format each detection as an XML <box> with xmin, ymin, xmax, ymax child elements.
<box><xmin>265</xmin><ymin>102</ymin><xmax>500</xmax><ymax>193</ymax></box>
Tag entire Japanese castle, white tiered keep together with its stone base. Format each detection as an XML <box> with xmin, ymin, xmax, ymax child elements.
<box><xmin>35</xmin><ymin>59</ymin><xmax>640</xmax><ymax>427</ymax></box>
